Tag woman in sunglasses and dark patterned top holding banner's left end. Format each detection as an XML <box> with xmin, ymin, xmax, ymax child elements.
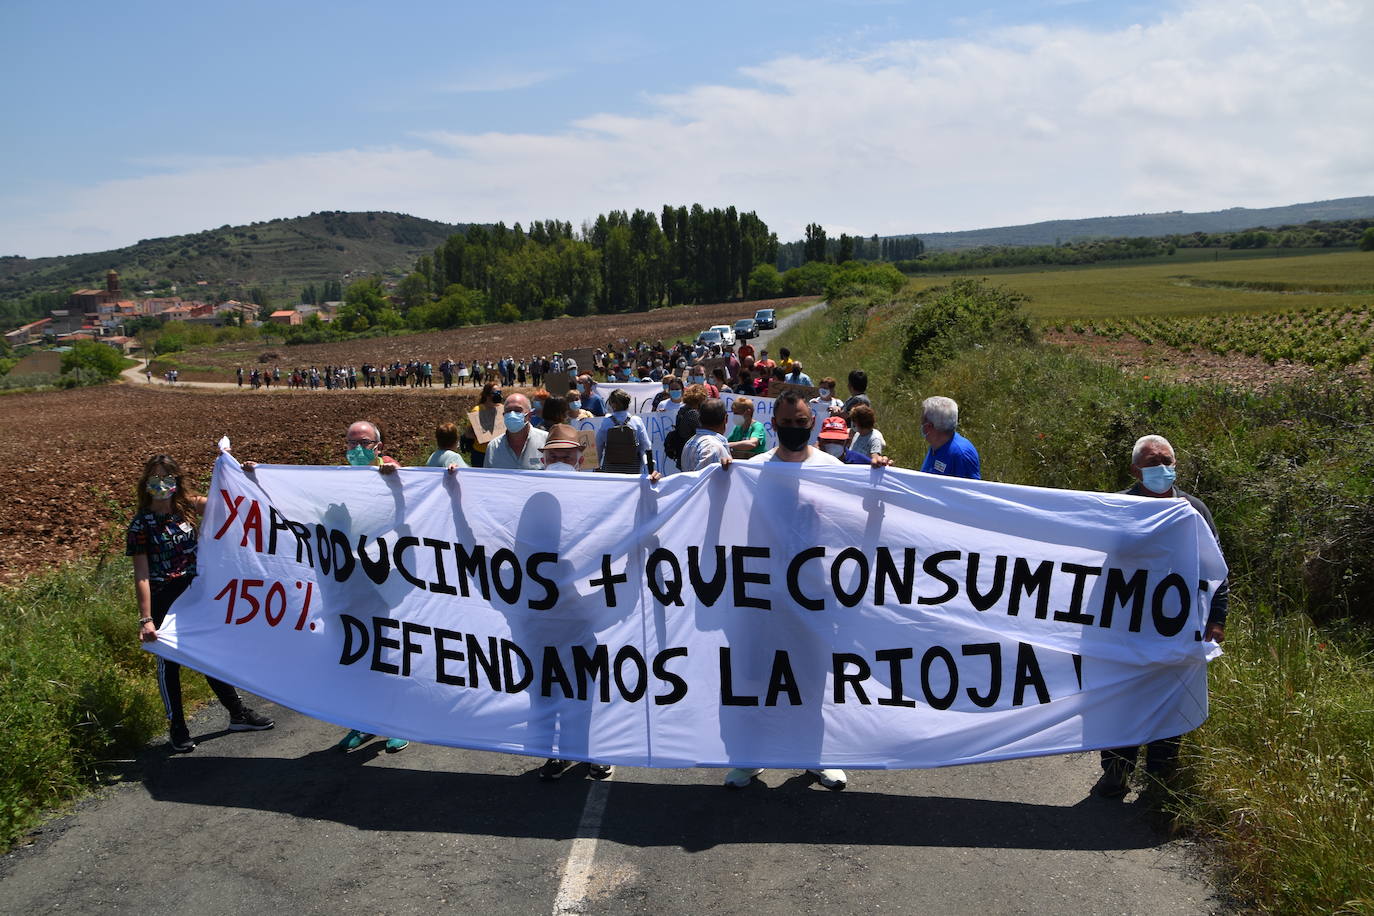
<box><xmin>125</xmin><ymin>455</ymin><xmax>275</xmax><ymax>754</ymax></box>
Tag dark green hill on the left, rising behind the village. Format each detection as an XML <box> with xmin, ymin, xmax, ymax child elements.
<box><xmin>0</xmin><ymin>211</ymin><xmax>462</xmax><ymax>299</ymax></box>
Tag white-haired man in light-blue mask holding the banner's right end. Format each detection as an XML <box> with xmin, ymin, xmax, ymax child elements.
<box><xmin>1092</xmin><ymin>435</ymin><xmax>1230</xmax><ymax>798</ymax></box>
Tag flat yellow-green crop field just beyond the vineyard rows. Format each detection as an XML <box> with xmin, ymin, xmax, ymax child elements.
<box><xmin>918</xmin><ymin>251</ymin><xmax>1374</xmax><ymax>321</ymax></box>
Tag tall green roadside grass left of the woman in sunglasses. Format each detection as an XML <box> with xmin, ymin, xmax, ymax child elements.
<box><xmin>0</xmin><ymin>558</ymin><xmax>209</xmax><ymax>846</ymax></box>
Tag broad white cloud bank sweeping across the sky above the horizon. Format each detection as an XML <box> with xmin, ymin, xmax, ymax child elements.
<box><xmin>0</xmin><ymin>0</ymin><xmax>1374</xmax><ymax>254</ymax></box>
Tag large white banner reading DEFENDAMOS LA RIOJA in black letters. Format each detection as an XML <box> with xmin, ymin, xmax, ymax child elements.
<box><xmin>150</xmin><ymin>453</ymin><xmax>1226</xmax><ymax>768</ymax></box>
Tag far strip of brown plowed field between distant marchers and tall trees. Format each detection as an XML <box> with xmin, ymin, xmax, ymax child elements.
<box><xmin>162</xmin><ymin>297</ymin><xmax>816</xmax><ymax>382</ymax></box>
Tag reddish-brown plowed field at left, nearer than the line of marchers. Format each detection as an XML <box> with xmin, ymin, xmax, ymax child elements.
<box><xmin>0</xmin><ymin>385</ymin><xmax>475</xmax><ymax>582</ymax></box>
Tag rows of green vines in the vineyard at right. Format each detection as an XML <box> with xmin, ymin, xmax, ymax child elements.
<box><xmin>1046</xmin><ymin>305</ymin><xmax>1374</xmax><ymax>368</ymax></box>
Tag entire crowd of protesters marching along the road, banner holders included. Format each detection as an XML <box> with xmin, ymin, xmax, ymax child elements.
<box><xmin>128</xmin><ymin>343</ymin><xmax>1227</xmax><ymax>797</ymax></box>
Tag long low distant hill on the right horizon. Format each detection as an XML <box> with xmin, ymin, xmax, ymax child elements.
<box><xmin>916</xmin><ymin>196</ymin><xmax>1374</xmax><ymax>251</ymax></box>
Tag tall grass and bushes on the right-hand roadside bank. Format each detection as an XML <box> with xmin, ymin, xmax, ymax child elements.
<box><xmin>778</xmin><ymin>284</ymin><xmax>1374</xmax><ymax>913</ymax></box>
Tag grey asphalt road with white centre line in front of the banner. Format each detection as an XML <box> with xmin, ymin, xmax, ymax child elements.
<box><xmin>0</xmin><ymin>692</ymin><xmax>1219</xmax><ymax>916</ymax></box>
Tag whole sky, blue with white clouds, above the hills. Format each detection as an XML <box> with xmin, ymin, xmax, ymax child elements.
<box><xmin>0</xmin><ymin>0</ymin><xmax>1374</xmax><ymax>257</ymax></box>
